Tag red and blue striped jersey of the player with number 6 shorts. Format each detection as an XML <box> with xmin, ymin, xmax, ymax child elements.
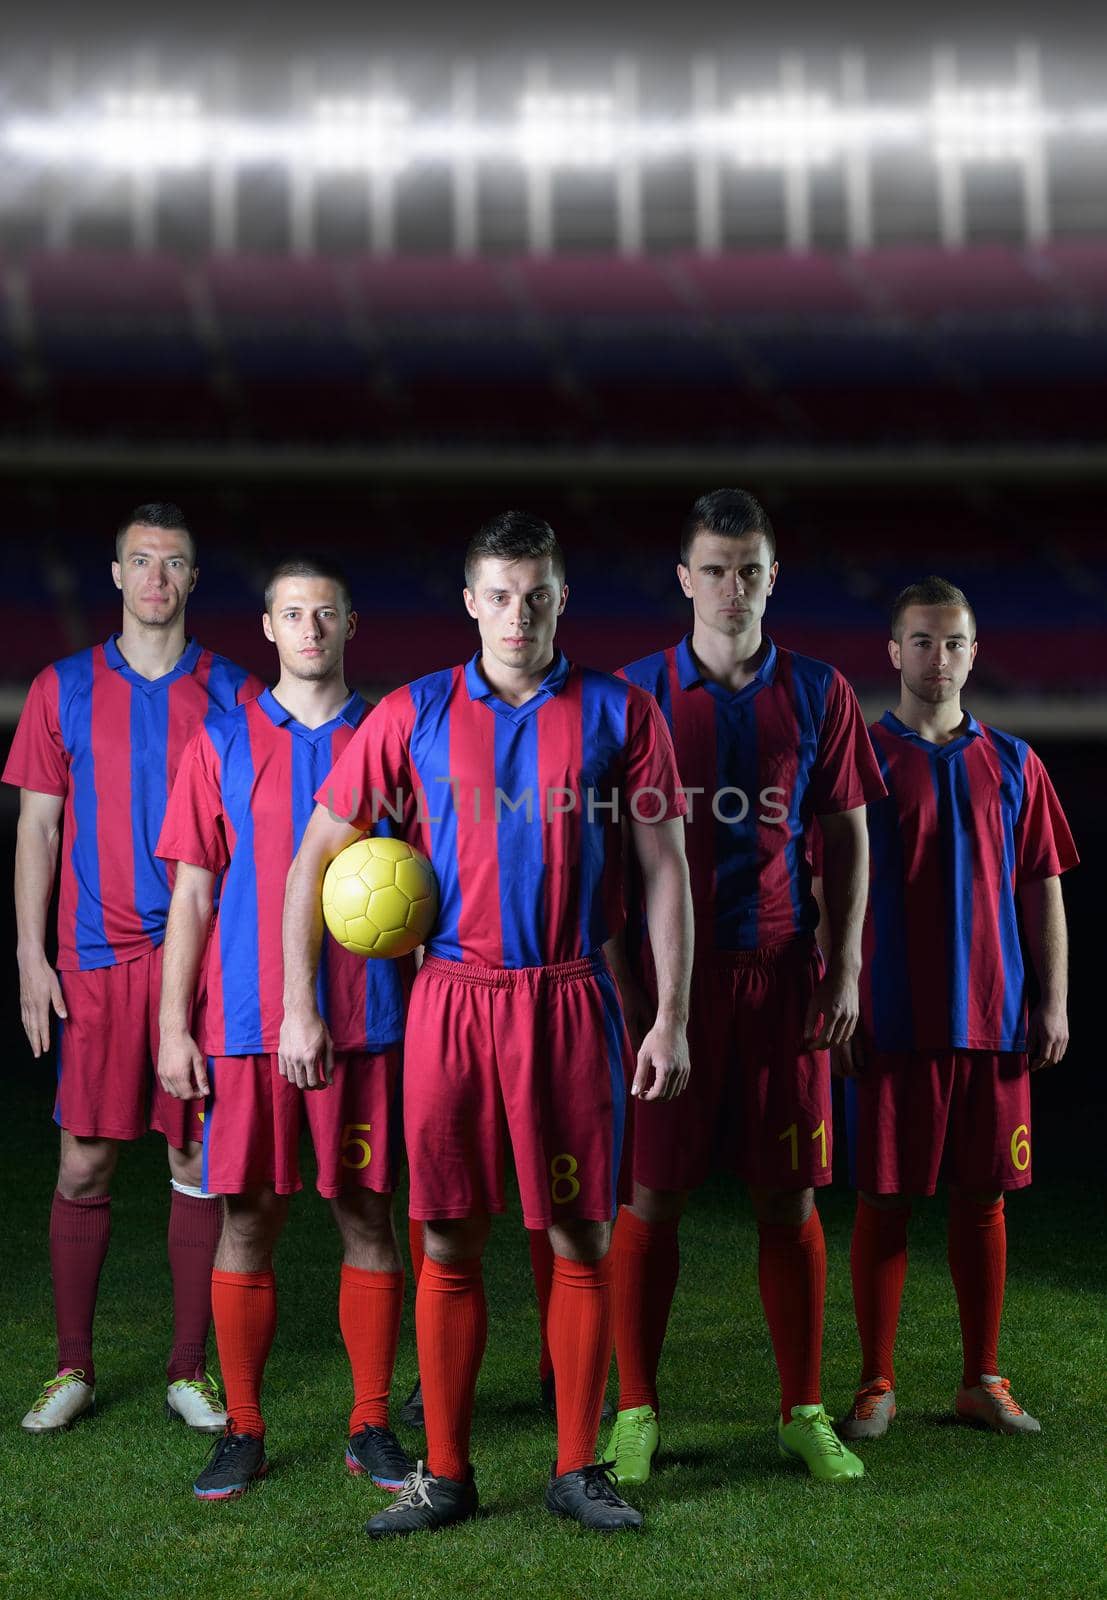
<box><xmin>862</xmin><ymin>712</ymin><xmax>1078</xmax><ymax>1051</ymax></box>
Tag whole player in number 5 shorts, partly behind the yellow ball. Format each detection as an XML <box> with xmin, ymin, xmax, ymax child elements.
<box><xmin>158</xmin><ymin>557</ymin><xmax>411</xmax><ymax>1499</ymax></box>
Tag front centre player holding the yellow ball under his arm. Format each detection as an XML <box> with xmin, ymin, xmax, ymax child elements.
<box><xmin>282</xmin><ymin>512</ymin><xmax>691</xmax><ymax>1538</ymax></box>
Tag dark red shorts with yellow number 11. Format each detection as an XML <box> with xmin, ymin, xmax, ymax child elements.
<box><xmin>633</xmin><ymin>939</ymin><xmax>832</xmax><ymax>1189</ymax></box>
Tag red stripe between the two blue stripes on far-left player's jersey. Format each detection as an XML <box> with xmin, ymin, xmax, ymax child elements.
<box><xmin>90</xmin><ymin>650</ymin><xmax>135</xmax><ymax>960</ymax></box>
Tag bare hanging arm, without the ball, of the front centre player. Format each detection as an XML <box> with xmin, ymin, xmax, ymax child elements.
<box><xmin>630</xmin><ymin>818</ymin><xmax>693</xmax><ymax>1099</ymax></box>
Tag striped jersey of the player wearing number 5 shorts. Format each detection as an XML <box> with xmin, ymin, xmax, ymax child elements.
<box><xmin>158</xmin><ymin>690</ymin><xmax>403</xmax><ymax>1056</ymax></box>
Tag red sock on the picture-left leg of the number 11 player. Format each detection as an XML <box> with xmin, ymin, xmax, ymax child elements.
<box><xmin>608</xmin><ymin>1206</ymin><xmax>680</xmax><ymax>1411</ymax></box>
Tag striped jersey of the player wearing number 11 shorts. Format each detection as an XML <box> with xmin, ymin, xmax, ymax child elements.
<box><xmin>621</xmin><ymin>635</ymin><xmax>885</xmax><ymax>950</ymax></box>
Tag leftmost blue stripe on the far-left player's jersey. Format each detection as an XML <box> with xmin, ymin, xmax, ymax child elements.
<box><xmin>54</xmin><ymin>650</ymin><xmax>109</xmax><ymax>971</ymax></box>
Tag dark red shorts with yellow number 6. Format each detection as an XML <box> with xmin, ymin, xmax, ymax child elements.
<box><xmin>846</xmin><ymin>1050</ymin><xmax>1030</xmax><ymax>1195</ymax></box>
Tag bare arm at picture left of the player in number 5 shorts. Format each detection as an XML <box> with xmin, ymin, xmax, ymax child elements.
<box><xmin>158</xmin><ymin>861</ymin><xmax>214</xmax><ymax>1099</ymax></box>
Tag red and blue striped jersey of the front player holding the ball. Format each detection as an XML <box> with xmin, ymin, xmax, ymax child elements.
<box><xmin>317</xmin><ymin>654</ymin><xmax>685</xmax><ymax>966</ymax></box>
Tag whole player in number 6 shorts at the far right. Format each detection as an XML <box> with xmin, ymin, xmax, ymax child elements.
<box><xmin>838</xmin><ymin>578</ymin><xmax>1077</xmax><ymax>1438</ymax></box>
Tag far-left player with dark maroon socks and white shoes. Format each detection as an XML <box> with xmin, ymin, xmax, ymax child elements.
<box><xmin>3</xmin><ymin>502</ymin><xmax>262</xmax><ymax>1434</ymax></box>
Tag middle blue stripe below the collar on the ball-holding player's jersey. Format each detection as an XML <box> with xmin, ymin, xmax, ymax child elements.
<box><xmin>493</xmin><ymin>720</ymin><xmax>546</xmax><ymax>966</ymax></box>
